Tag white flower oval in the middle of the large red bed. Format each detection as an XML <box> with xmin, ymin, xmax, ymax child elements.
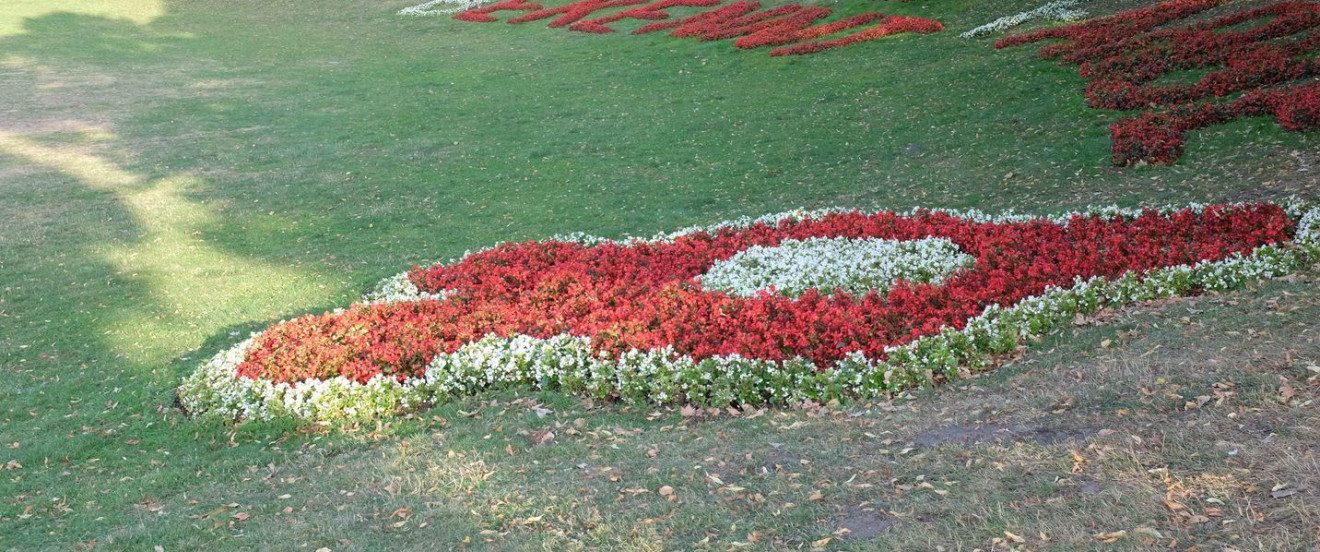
<box><xmin>698</xmin><ymin>238</ymin><xmax>977</xmax><ymax>297</ymax></box>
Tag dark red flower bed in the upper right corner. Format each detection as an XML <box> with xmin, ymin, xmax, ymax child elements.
<box><xmin>995</xmin><ymin>0</ymin><xmax>1320</xmax><ymax>165</ymax></box>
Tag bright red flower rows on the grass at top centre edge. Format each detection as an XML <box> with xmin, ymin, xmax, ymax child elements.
<box><xmin>446</xmin><ymin>0</ymin><xmax>944</xmax><ymax>55</ymax></box>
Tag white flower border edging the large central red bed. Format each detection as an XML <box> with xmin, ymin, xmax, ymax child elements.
<box><xmin>178</xmin><ymin>199</ymin><xmax>1320</xmax><ymax>420</ymax></box>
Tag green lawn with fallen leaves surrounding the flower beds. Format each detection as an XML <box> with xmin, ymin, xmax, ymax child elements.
<box><xmin>0</xmin><ymin>0</ymin><xmax>1320</xmax><ymax>551</ymax></box>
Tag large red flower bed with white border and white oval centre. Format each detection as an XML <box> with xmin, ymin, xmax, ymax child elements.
<box><xmin>180</xmin><ymin>203</ymin><xmax>1320</xmax><ymax>419</ymax></box>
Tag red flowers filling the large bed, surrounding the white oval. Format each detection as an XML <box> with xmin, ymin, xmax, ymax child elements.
<box><xmin>238</xmin><ymin>205</ymin><xmax>1292</xmax><ymax>382</ymax></box>
